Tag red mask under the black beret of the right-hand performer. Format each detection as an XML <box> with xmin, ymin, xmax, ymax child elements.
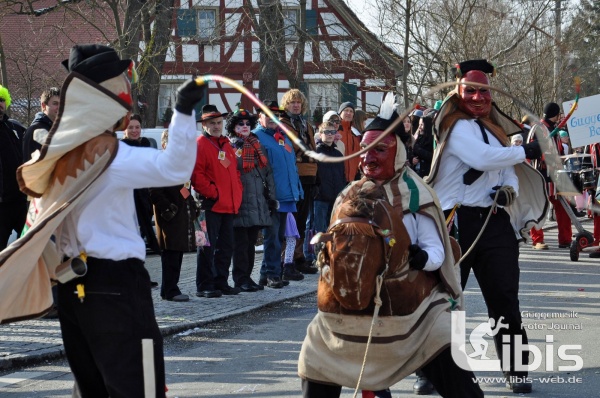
<box><xmin>458</xmin><ymin>70</ymin><xmax>492</xmax><ymax>118</ymax></box>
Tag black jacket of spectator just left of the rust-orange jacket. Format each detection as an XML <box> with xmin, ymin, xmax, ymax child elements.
<box><xmin>315</xmin><ymin>142</ymin><xmax>346</xmax><ymax>202</ymax></box>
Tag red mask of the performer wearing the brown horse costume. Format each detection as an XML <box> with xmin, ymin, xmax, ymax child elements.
<box><xmin>359</xmin><ymin>130</ymin><xmax>397</xmax><ymax>181</ymax></box>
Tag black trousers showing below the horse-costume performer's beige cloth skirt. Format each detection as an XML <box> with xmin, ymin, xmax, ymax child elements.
<box><xmin>302</xmin><ymin>347</ymin><xmax>483</xmax><ymax>398</ymax></box>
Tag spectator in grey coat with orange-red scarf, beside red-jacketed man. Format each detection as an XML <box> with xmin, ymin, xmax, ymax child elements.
<box><xmin>225</xmin><ymin>105</ymin><xmax>279</xmax><ymax>292</ymax></box>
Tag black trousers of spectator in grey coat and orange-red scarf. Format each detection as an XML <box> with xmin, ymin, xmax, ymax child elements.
<box><xmin>231</xmin><ymin>226</ymin><xmax>261</xmax><ymax>286</ymax></box>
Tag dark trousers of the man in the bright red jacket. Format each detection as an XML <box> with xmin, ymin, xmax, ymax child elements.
<box><xmin>196</xmin><ymin>210</ymin><xmax>233</xmax><ymax>291</ymax></box>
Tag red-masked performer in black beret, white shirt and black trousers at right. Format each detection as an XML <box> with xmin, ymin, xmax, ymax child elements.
<box><xmin>425</xmin><ymin>60</ymin><xmax>548</xmax><ymax>393</ymax></box>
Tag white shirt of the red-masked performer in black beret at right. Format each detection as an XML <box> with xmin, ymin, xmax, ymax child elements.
<box><xmin>433</xmin><ymin>119</ymin><xmax>525</xmax><ymax>210</ymax></box>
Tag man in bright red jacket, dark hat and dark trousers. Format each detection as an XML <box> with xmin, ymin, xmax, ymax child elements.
<box><xmin>192</xmin><ymin>105</ymin><xmax>242</xmax><ymax>298</ymax></box>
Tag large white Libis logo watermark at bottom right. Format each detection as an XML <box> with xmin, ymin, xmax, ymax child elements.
<box><xmin>451</xmin><ymin>311</ymin><xmax>583</xmax><ymax>372</ymax></box>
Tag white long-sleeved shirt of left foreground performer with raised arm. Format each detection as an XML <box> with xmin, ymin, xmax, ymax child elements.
<box><xmin>57</xmin><ymin>111</ymin><xmax>196</xmax><ymax>260</ymax></box>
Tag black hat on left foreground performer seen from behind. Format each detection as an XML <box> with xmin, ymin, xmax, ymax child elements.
<box><xmin>62</xmin><ymin>44</ymin><xmax>131</xmax><ymax>83</ymax></box>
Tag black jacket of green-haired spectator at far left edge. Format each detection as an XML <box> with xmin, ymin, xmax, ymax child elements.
<box><xmin>0</xmin><ymin>115</ymin><xmax>27</xmax><ymax>202</ymax></box>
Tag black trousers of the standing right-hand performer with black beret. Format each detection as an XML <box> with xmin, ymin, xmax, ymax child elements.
<box><xmin>457</xmin><ymin>206</ymin><xmax>529</xmax><ymax>377</ymax></box>
